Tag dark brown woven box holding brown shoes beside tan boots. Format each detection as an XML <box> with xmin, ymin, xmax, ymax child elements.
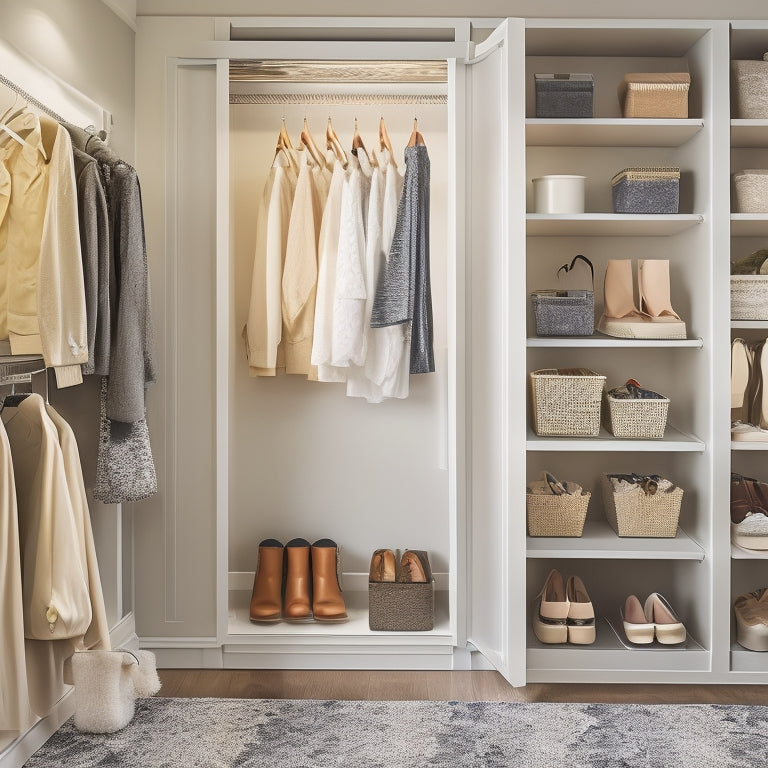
<box><xmin>368</xmin><ymin>551</ymin><xmax>435</xmax><ymax>632</ymax></box>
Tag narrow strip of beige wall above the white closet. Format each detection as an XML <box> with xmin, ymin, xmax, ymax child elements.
<box><xmin>137</xmin><ymin>0</ymin><xmax>768</xmax><ymax>19</ymax></box>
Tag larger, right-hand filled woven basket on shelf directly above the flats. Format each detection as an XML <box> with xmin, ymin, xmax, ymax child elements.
<box><xmin>602</xmin><ymin>475</ymin><xmax>683</xmax><ymax>538</ymax></box>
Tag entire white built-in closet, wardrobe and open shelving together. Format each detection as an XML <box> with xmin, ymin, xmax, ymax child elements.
<box><xmin>135</xmin><ymin>17</ymin><xmax>768</xmax><ymax>685</ymax></box>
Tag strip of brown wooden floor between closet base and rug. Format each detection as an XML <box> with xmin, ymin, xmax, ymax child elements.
<box><xmin>157</xmin><ymin>669</ymin><xmax>768</xmax><ymax>704</ymax></box>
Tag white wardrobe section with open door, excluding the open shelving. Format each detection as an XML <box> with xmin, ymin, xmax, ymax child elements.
<box><xmin>136</xmin><ymin>19</ymin><xmax>524</xmax><ymax>684</ymax></box>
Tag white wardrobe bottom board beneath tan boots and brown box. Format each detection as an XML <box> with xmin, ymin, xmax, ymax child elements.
<box><xmin>224</xmin><ymin>590</ymin><xmax>453</xmax><ymax>652</ymax></box>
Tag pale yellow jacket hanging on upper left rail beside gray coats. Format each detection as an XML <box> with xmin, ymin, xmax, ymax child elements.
<box><xmin>0</xmin><ymin>105</ymin><xmax>88</xmax><ymax>387</ymax></box>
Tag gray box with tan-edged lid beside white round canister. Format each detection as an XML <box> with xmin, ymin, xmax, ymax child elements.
<box><xmin>611</xmin><ymin>168</ymin><xmax>680</xmax><ymax>213</ymax></box>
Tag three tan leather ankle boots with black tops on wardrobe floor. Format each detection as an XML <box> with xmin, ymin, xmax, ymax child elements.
<box><xmin>250</xmin><ymin>539</ymin><xmax>347</xmax><ymax>622</ymax></box>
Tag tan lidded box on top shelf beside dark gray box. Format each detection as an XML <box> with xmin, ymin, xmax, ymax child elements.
<box><xmin>619</xmin><ymin>72</ymin><xmax>691</xmax><ymax>118</ymax></box>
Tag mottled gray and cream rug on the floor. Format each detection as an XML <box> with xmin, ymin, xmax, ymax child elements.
<box><xmin>21</xmin><ymin>699</ymin><xmax>768</xmax><ymax>768</ymax></box>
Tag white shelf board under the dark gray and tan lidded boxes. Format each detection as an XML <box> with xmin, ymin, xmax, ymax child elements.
<box><xmin>525</xmin><ymin>117</ymin><xmax>704</xmax><ymax>147</ymax></box>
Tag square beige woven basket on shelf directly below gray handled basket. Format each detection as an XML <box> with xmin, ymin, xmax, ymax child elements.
<box><xmin>531</xmin><ymin>368</ymin><xmax>605</xmax><ymax>437</ymax></box>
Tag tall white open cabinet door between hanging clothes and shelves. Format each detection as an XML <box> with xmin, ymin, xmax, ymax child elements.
<box><xmin>467</xmin><ymin>19</ymin><xmax>526</xmax><ymax>685</ymax></box>
